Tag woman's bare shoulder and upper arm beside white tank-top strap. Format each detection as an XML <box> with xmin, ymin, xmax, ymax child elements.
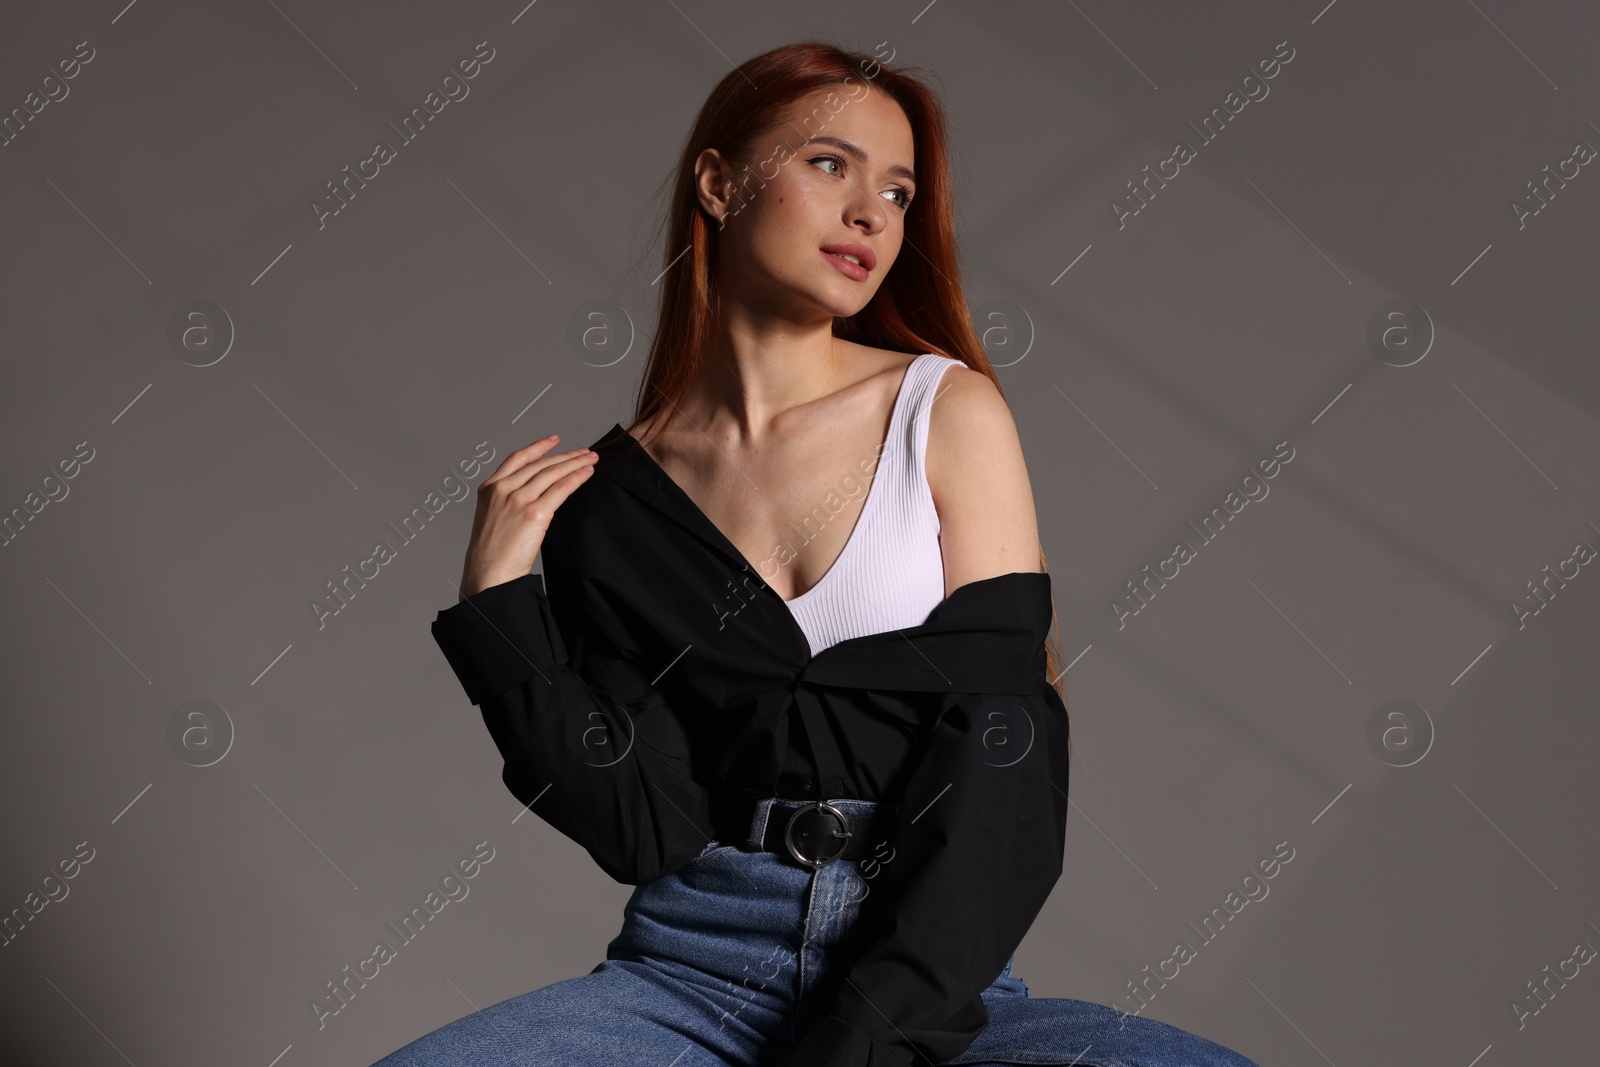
<box><xmin>925</xmin><ymin>365</ymin><xmax>1038</xmax><ymax>593</ymax></box>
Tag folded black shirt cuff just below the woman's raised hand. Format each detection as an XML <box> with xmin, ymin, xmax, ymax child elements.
<box><xmin>432</xmin><ymin>574</ymin><xmax>566</xmax><ymax>704</ymax></box>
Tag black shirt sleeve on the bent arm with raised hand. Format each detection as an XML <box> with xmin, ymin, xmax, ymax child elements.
<box><xmin>432</xmin><ymin>574</ymin><xmax>712</xmax><ymax>885</ymax></box>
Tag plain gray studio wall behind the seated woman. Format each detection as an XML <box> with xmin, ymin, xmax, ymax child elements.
<box><xmin>0</xmin><ymin>0</ymin><xmax>1600</xmax><ymax>1067</ymax></box>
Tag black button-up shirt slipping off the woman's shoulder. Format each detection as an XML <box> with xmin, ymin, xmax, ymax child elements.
<box><xmin>432</xmin><ymin>424</ymin><xmax>1069</xmax><ymax>1067</ymax></box>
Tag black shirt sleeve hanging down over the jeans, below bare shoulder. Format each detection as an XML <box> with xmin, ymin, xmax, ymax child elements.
<box><xmin>778</xmin><ymin>688</ymin><xmax>1067</xmax><ymax>1067</ymax></box>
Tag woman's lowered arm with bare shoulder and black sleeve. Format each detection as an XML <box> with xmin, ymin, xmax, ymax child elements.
<box><xmin>776</xmin><ymin>379</ymin><xmax>1067</xmax><ymax>1067</ymax></box>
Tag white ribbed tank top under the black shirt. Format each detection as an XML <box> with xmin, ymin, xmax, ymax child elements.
<box><xmin>786</xmin><ymin>352</ymin><xmax>962</xmax><ymax>656</ymax></box>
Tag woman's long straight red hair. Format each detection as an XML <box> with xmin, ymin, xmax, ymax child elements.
<box><xmin>604</xmin><ymin>40</ymin><xmax>1072</xmax><ymax>752</ymax></box>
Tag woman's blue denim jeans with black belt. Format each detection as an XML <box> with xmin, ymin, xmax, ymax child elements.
<box><xmin>374</xmin><ymin>800</ymin><xmax>1256</xmax><ymax>1067</ymax></box>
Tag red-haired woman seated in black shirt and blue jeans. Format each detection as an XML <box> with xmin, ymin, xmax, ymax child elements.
<box><xmin>381</xmin><ymin>42</ymin><xmax>1251</xmax><ymax>1067</ymax></box>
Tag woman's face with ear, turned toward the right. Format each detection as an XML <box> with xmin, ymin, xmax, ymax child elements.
<box><xmin>696</xmin><ymin>82</ymin><xmax>917</xmax><ymax>322</ymax></box>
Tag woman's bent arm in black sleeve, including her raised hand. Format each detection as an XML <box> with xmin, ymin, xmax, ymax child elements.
<box><xmin>434</xmin><ymin>435</ymin><xmax>710</xmax><ymax>885</ymax></box>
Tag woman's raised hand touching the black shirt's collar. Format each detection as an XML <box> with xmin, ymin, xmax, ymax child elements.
<box><xmin>461</xmin><ymin>434</ymin><xmax>600</xmax><ymax>600</ymax></box>
